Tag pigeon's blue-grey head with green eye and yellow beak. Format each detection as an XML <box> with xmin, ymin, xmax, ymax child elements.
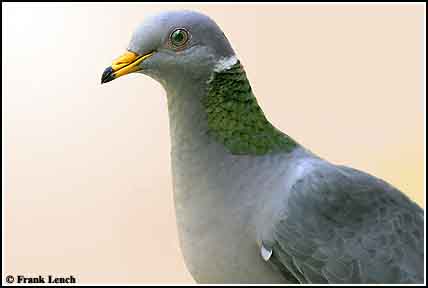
<box><xmin>101</xmin><ymin>10</ymin><xmax>234</xmax><ymax>85</ymax></box>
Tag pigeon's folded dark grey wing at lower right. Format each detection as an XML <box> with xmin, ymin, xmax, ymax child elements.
<box><xmin>263</xmin><ymin>164</ymin><xmax>424</xmax><ymax>283</ymax></box>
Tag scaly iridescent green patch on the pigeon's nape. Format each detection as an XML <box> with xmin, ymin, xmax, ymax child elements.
<box><xmin>203</xmin><ymin>61</ymin><xmax>298</xmax><ymax>155</ymax></box>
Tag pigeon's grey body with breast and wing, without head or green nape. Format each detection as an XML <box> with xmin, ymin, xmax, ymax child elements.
<box><xmin>167</xmin><ymin>58</ymin><xmax>423</xmax><ymax>283</ymax></box>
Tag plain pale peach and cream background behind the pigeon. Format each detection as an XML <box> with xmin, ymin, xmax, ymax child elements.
<box><xmin>2</xmin><ymin>3</ymin><xmax>425</xmax><ymax>283</ymax></box>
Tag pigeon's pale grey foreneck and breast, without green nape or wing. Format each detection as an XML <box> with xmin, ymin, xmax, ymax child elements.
<box><xmin>167</xmin><ymin>59</ymin><xmax>306</xmax><ymax>283</ymax></box>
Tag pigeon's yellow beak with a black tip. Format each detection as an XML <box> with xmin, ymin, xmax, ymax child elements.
<box><xmin>101</xmin><ymin>51</ymin><xmax>154</xmax><ymax>84</ymax></box>
